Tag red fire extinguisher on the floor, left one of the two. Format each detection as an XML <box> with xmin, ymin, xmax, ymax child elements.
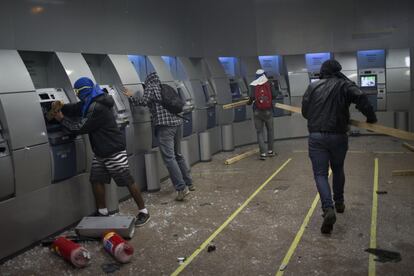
<box><xmin>52</xmin><ymin>237</ymin><xmax>91</xmax><ymax>267</ymax></box>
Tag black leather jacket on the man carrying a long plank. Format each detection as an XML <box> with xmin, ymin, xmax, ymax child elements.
<box><xmin>302</xmin><ymin>76</ymin><xmax>377</xmax><ymax>133</ymax></box>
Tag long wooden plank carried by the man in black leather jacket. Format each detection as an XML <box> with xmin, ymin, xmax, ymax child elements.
<box><xmin>275</xmin><ymin>103</ymin><xmax>414</xmax><ymax>141</ymax></box>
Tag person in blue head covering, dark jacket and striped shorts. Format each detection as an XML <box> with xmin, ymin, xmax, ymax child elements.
<box><xmin>55</xmin><ymin>77</ymin><xmax>150</xmax><ymax>226</ymax></box>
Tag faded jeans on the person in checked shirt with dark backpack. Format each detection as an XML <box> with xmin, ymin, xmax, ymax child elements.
<box><xmin>155</xmin><ymin>126</ymin><xmax>192</xmax><ymax>191</ymax></box>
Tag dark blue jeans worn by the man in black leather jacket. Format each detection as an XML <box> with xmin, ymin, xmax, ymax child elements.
<box><xmin>308</xmin><ymin>132</ymin><xmax>348</xmax><ymax>209</ymax></box>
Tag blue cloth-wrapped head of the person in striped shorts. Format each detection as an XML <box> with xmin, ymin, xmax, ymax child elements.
<box><xmin>74</xmin><ymin>77</ymin><xmax>103</xmax><ymax>117</ymax></box>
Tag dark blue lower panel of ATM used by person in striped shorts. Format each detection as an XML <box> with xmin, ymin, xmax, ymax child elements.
<box><xmin>51</xmin><ymin>141</ymin><xmax>76</xmax><ymax>182</ymax></box>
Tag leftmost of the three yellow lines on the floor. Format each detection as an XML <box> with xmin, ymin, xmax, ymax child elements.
<box><xmin>171</xmin><ymin>158</ymin><xmax>292</xmax><ymax>276</ymax></box>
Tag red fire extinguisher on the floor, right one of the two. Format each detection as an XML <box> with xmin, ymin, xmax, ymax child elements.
<box><xmin>103</xmin><ymin>232</ymin><xmax>134</xmax><ymax>263</ymax></box>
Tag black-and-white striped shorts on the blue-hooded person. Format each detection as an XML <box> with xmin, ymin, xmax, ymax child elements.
<box><xmin>89</xmin><ymin>150</ymin><xmax>135</xmax><ymax>187</ymax></box>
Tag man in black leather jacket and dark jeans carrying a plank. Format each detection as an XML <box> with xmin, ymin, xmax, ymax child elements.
<box><xmin>302</xmin><ymin>60</ymin><xmax>377</xmax><ymax>234</ymax></box>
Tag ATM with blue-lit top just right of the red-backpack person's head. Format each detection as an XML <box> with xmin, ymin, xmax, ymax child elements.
<box><xmin>259</xmin><ymin>55</ymin><xmax>290</xmax><ymax>117</ymax></box>
